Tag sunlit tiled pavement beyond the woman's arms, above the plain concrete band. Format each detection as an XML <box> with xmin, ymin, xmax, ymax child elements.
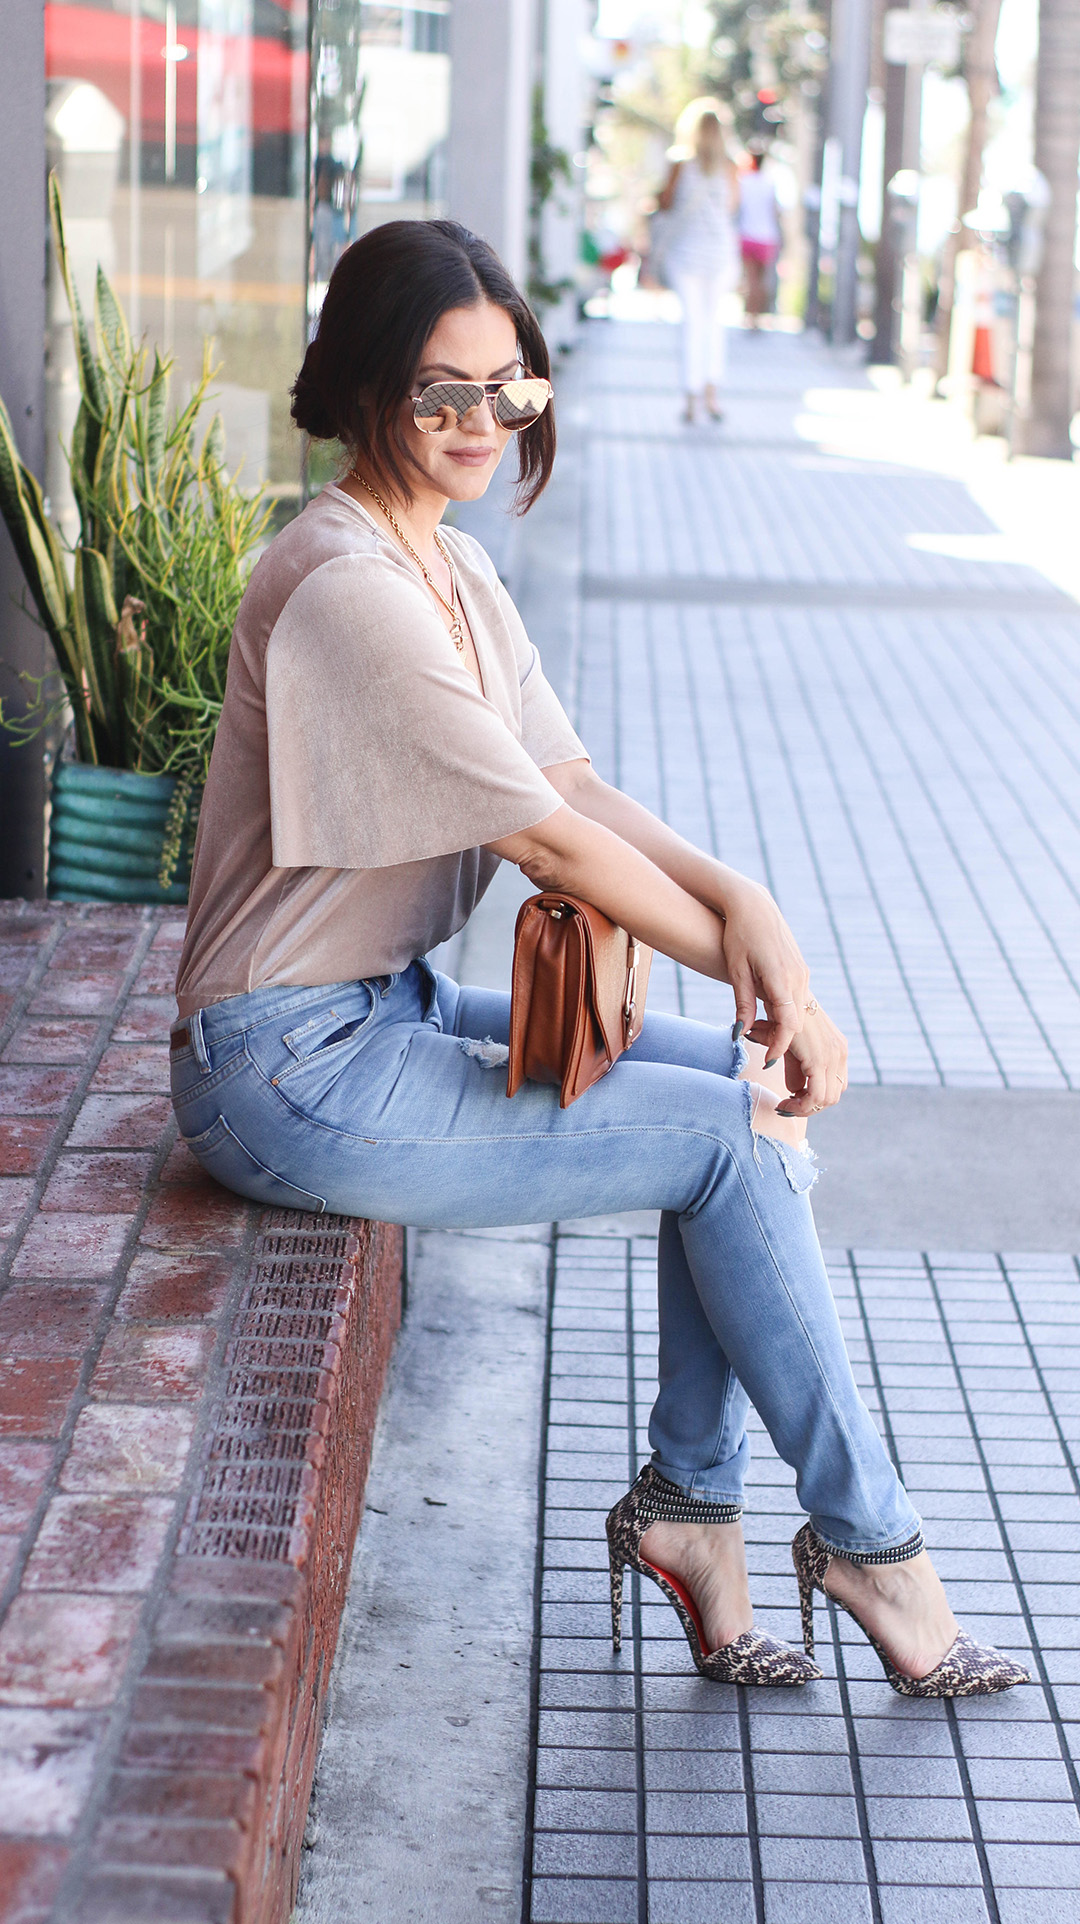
<box><xmin>578</xmin><ymin>323</ymin><xmax>1080</xmax><ymax>1089</ymax></box>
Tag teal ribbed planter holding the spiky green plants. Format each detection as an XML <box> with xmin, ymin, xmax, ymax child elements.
<box><xmin>48</xmin><ymin>762</ymin><xmax>200</xmax><ymax>902</ymax></box>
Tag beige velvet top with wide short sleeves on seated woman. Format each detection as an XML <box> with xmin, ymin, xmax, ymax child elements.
<box><xmin>177</xmin><ymin>487</ymin><xmax>585</xmax><ymax>1016</ymax></box>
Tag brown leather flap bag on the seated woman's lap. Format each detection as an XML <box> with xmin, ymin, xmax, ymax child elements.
<box><xmin>506</xmin><ymin>895</ymin><xmax>653</xmax><ymax>1108</ymax></box>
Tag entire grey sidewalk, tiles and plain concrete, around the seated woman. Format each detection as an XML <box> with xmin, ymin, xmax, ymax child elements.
<box><xmin>298</xmin><ymin>323</ymin><xmax>1080</xmax><ymax>1924</ymax></box>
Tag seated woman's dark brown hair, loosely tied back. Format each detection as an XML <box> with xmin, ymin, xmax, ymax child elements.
<box><xmin>293</xmin><ymin>221</ymin><xmax>554</xmax><ymax>514</ymax></box>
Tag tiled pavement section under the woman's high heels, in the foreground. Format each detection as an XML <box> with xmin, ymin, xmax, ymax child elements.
<box><xmin>531</xmin><ymin>1224</ymin><xmax>1080</xmax><ymax>1924</ymax></box>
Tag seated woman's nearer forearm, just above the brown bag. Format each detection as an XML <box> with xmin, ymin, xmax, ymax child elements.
<box><xmin>491</xmin><ymin>806</ymin><xmax>728</xmax><ymax>981</ymax></box>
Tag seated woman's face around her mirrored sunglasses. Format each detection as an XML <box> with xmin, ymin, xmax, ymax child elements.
<box><xmin>402</xmin><ymin>300</ymin><xmax>520</xmax><ymax>500</ymax></box>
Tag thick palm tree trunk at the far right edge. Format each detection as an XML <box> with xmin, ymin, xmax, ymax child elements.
<box><xmin>1022</xmin><ymin>0</ymin><xmax>1080</xmax><ymax>460</ymax></box>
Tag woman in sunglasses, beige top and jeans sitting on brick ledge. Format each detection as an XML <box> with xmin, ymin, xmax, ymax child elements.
<box><xmin>171</xmin><ymin>221</ymin><xmax>1026</xmax><ymax>1697</ymax></box>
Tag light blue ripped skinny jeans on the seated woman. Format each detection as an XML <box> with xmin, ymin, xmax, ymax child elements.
<box><xmin>171</xmin><ymin>962</ymin><xmax>918</xmax><ymax>1557</ymax></box>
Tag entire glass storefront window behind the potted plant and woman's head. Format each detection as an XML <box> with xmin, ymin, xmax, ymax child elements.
<box><xmin>44</xmin><ymin>0</ymin><xmax>450</xmax><ymax>523</ymax></box>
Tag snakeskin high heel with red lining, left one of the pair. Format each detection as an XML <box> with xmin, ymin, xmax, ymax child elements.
<box><xmin>606</xmin><ymin>1464</ymin><xmax>822</xmax><ymax>1685</ymax></box>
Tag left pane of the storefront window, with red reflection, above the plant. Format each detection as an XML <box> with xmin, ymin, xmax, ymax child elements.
<box><xmin>44</xmin><ymin>0</ymin><xmax>308</xmax><ymax>527</ymax></box>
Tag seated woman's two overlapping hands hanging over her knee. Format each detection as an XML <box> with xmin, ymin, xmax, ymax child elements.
<box><xmin>724</xmin><ymin>877</ymin><xmax>847</xmax><ymax>1116</ymax></box>
